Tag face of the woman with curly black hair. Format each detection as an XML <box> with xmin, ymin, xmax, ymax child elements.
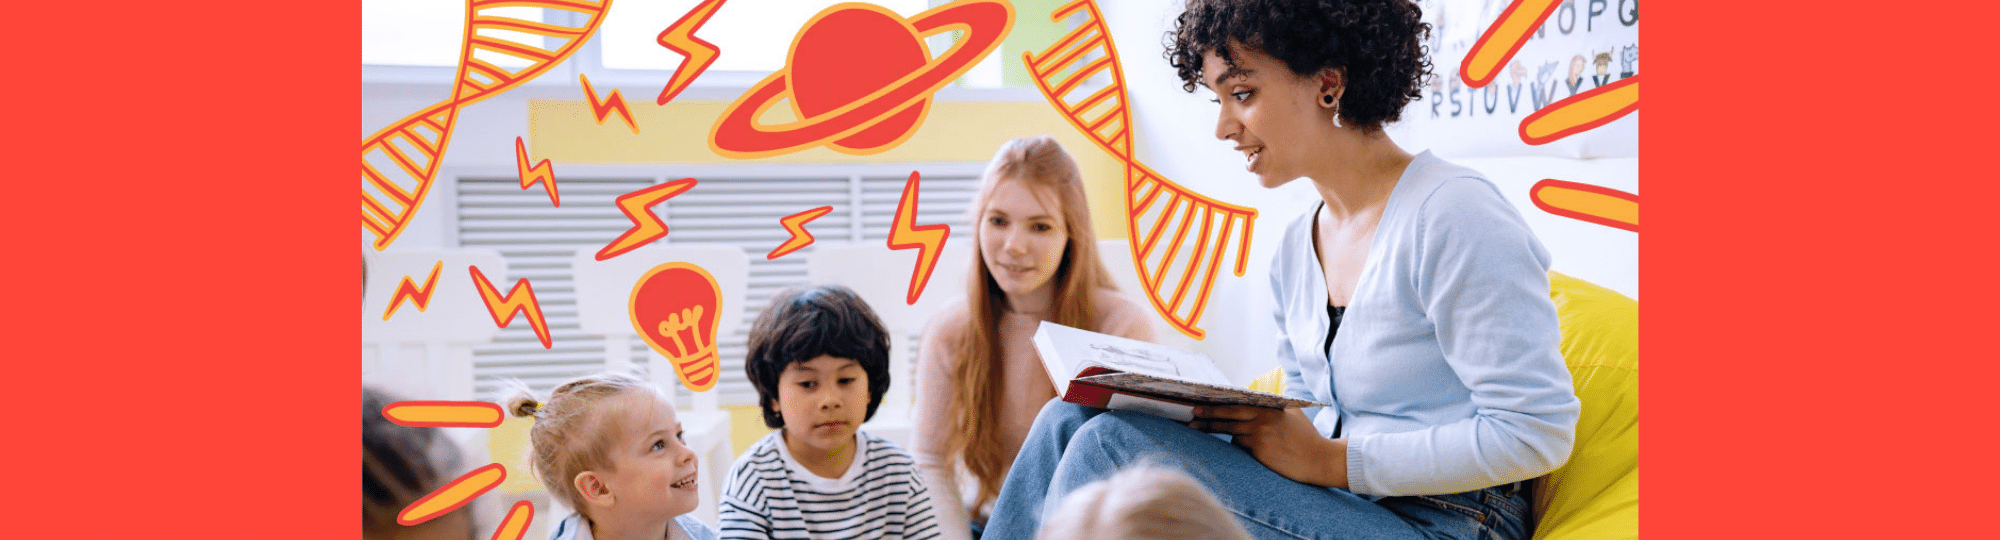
<box><xmin>1202</xmin><ymin>46</ymin><xmax>1334</xmax><ymax>188</ymax></box>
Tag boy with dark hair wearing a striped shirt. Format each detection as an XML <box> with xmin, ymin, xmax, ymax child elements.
<box><xmin>718</xmin><ymin>286</ymin><xmax>940</xmax><ymax>540</ymax></box>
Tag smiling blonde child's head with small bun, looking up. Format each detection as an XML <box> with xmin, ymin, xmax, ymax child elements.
<box><xmin>506</xmin><ymin>374</ymin><xmax>700</xmax><ymax>524</ymax></box>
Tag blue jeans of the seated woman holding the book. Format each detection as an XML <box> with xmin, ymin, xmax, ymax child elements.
<box><xmin>984</xmin><ymin>400</ymin><xmax>1532</xmax><ymax>540</ymax></box>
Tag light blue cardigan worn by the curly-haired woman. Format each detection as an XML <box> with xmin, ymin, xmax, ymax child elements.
<box><xmin>1270</xmin><ymin>152</ymin><xmax>1582</xmax><ymax>496</ymax></box>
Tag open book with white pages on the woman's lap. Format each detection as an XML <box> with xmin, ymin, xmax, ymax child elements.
<box><xmin>1034</xmin><ymin>320</ymin><xmax>1326</xmax><ymax>422</ymax></box>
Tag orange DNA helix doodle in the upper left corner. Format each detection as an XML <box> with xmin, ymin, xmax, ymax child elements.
<box><xmin>362</xmin><ymin>0</ymin><xmax>612</xmax><ymax>250</ymax></box>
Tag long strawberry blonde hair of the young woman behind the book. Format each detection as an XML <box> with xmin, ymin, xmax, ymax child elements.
<box><xmin>944</xmin><ymin>136</ymin><xmax>1116</xmax><ymax>508</ymax></box>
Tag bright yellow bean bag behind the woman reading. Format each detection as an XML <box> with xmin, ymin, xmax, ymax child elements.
<box><xmin>1250</xmin><ymin>272</ymin><xmax>1638</xmax><ymax>540</ymax></box>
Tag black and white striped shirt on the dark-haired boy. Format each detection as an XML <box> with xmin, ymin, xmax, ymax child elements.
<box><xmin>716</xmin><ymin>430</ymin><xmax>940</xmax><ymax>540</ymax></box>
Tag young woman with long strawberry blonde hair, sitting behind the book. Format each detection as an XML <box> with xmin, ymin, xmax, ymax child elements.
<box><xmin>916</xmin><ymin>136</ymin><xmax>1154</xmax><ymax>538</ymax></box>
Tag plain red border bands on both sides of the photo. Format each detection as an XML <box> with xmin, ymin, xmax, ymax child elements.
<box><xmin>15</xmin><ymin>0</ymin><xmax>2000</xmax><ymax>538</ymax></box>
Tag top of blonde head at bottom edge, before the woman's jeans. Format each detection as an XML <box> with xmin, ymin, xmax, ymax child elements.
<box><xmin>1038</xmin><ymin>464</ymin><xmax>1250</xmax><ymax>540</ymax></box>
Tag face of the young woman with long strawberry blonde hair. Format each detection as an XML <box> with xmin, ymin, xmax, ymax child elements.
<box><xmin>980</xmin><ymin>178</ymin><xmax>1070</xmax><ymax>302</ymax></box>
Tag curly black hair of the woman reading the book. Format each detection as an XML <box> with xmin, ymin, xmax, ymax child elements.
<box><xmin>1166</xmin><ymin>0</ymin><xmax>1430</xmax><ymax>130</ymax></box>
